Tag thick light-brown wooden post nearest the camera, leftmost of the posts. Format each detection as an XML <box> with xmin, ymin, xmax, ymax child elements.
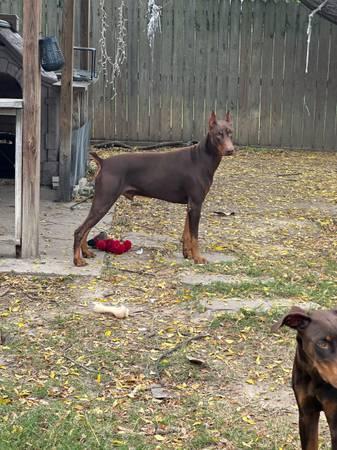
<box><xmin>21</xmin><ymin>0</ymin><xmax>41</xmax><ymax>258</ymax></box>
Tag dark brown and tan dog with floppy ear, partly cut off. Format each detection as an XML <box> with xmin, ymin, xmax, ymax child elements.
<box><xmin>272</xmin><ymin>307</ymin><xmax>337</xmax><ymax>450</ymax></box>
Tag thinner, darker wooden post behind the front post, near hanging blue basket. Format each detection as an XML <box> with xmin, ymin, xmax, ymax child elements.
<box><xmin>59</xmin><ymin>0</ymin><xmax>75</xmax><ymax>202</ymax></box>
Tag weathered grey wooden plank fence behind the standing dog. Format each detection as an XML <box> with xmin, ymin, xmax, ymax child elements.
<box><xmin>0</xmin><ymin>0</ymin><xmax>337</xmax><ymax>150</ymax></box>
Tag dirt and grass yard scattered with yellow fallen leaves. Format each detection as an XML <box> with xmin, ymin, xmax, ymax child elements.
<box><xmin>0</xmin><ymin>149</ymin><xmax>337</xmax><ymax>450</ymax></box>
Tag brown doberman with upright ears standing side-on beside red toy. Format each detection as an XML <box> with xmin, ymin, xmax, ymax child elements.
<box><xmin>74</xmin><ymin>112</ymin><xmax>234</xmax><ymax>266</ymax></box>
